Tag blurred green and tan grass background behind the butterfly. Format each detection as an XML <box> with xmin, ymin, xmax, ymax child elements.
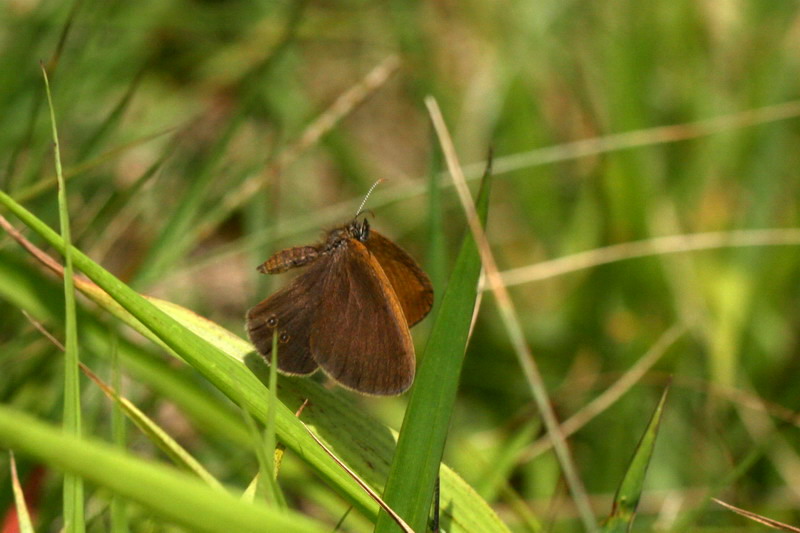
<box><xmin>0</xmin><ymin>0</ymin><xmax>800</xmax><ymax>531</ymax></box>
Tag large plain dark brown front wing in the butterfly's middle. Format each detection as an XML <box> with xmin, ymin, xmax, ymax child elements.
<box><xmin>310</xmin><ymin>239</ymin><xmax>416</xmax><ymax>395</ymax></box>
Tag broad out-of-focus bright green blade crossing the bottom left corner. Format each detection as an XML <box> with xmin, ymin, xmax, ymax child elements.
<box><xmin>0</xmin><ymin>406</ymin><xmax>328</xmax><ymax>533</ymax></box>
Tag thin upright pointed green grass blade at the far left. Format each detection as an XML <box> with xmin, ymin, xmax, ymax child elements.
<box><xmin>42</xmin><ymin>65</ymin><xmax>86</xmax><ymax>533</ymax></box>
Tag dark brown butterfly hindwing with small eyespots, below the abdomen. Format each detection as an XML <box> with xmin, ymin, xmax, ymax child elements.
<box><xmin>247</xmin><ymin>261</ymin><xmax>324</xmax><ymax>375</ymax></box>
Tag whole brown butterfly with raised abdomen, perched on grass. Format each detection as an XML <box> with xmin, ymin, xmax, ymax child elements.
<box><xmin>247</xmin><ymin>213</ymin><xmax>433</xmax><ymax>395</ymax></box>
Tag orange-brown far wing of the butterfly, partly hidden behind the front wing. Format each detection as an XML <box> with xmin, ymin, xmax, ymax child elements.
<box><xmin>366</xmin><ymin>230</ymin><xmax>433</xmax><ymax>327</ymax></box>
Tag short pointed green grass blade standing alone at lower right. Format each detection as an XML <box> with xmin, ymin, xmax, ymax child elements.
<box><xmin>602</xmin><ymin>389</ymin><xmax>669</xmax><ymax>533</ymax></box>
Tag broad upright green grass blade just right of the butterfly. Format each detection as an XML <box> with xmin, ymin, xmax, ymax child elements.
<box><xmin>375</xmin><ymin>166</ymin><xmax>491</xmax><ymax>533</ymax></box>
